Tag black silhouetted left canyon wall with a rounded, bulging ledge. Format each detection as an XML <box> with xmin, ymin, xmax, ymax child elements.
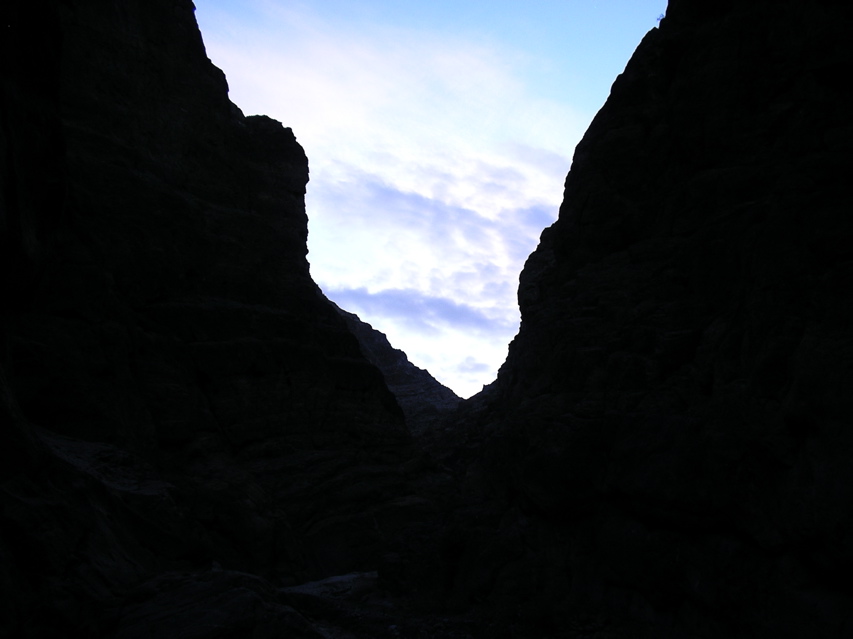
<box><xmin>0</xmin><ymin>0</ymin><xmax>434</xmax><ymax>637</ymax></box>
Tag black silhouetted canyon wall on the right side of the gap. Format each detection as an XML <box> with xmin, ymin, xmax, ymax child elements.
<box><xmin>442</xmin><ymin>0</ymin><xmax>853</xmax><ymax>637</ymax></box>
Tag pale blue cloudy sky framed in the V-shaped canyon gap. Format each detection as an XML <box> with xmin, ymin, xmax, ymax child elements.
<box><xmin>195</xmin><ymin>0</ymin><xmax>666</xmax><ymax>397</ymax></box>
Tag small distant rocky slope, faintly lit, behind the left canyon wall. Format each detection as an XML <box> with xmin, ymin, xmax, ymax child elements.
<box><xmin>338</xmin><ymin>308</ymin><xmax>461</xmax><ymax>435</ymax></box>
